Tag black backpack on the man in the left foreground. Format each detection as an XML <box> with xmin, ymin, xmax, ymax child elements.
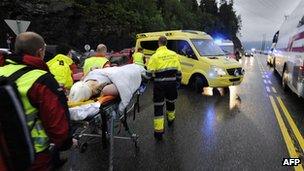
<box><xmin>0</xmin><ymin>67</ymin><xmax>35</xmax><ymax>170</ymax></box>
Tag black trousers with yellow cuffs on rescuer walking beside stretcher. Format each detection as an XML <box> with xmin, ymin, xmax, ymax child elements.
<box><xmin>153</xmin><ymin>81</ymin><xmax>177</xmax><ymax>133</ymax></box>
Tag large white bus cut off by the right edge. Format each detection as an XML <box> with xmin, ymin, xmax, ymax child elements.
<box><xmin>273</xmin><ymin>1</ymin><xmax>304</xmax><ymax>97</ymax></box>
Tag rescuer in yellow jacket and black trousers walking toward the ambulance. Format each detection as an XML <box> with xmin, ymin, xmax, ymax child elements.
<box><xmin>146</xmin><ymin>36</ymin><xmax>181</xmax><ymax>139</ymax></box>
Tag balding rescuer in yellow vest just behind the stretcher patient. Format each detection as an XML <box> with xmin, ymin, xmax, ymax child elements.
<box><xmin>83</xmin><ymin>44</ymin><xmax>110</xmax><ymax>75</ymax></box>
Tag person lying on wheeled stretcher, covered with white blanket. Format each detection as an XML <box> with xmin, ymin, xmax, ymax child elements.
<box><xmin>69</xmin><ymin>64</ymin><xmax>145</xmax><ymax>111</ymax></box>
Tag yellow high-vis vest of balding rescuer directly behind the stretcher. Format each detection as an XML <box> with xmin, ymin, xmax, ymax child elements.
<box><xmin>83</xmin><ymin>57</ymin><xmax>109</xmax><ymax>74</ymax></box>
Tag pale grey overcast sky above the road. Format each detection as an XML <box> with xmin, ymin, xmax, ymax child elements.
<box><xmin>234</xmin><ymin>0</ymin><xmax>301</xmax><ymax>41</ymax></box>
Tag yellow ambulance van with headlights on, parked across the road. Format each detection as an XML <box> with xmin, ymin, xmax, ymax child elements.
<box><xmin>135</xmin><ymin>30</ymin><xmax>245</xmax><ymax>90</ymax></box>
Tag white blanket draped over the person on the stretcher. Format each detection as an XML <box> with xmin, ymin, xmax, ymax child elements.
<box><xmin>84</xmin><ymin>64</ymin><xmax>145</xmax><ymax>112</ymax></box>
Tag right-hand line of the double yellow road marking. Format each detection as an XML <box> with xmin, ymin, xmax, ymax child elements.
<box><xmin>277</xmin><ymin>97</ymin><xmax>304</xmax><ymax>151</ymax></box>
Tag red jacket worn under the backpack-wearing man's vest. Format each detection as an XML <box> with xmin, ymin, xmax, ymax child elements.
<box><xmin>0</xmin><ymin>55</ymin><xmax>72</xmax><ymax>170</ymax></box>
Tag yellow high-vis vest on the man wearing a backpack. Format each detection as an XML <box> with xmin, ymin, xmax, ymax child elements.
<box><xmin>0</xmin><ymin>64</ymin><xmax>49</xmax><ymax>153</ymax></box>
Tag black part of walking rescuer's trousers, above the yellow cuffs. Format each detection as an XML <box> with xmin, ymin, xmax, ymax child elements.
<box><xmin>153</xmin><ymin>81</ymin><xmax>177</xmax><ymax>117</ymax></box>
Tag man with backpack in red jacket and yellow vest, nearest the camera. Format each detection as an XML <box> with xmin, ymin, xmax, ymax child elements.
<box><xmin>0</xmin><ymin>32</ymin><xmax>72</xmax><ymax>170</ymax></box>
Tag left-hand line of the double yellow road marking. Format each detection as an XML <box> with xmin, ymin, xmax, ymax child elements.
<box><xmin>269</xmin><ymin>96</ymin><xmax>303</xmax><ymax>171</ymax></box>
